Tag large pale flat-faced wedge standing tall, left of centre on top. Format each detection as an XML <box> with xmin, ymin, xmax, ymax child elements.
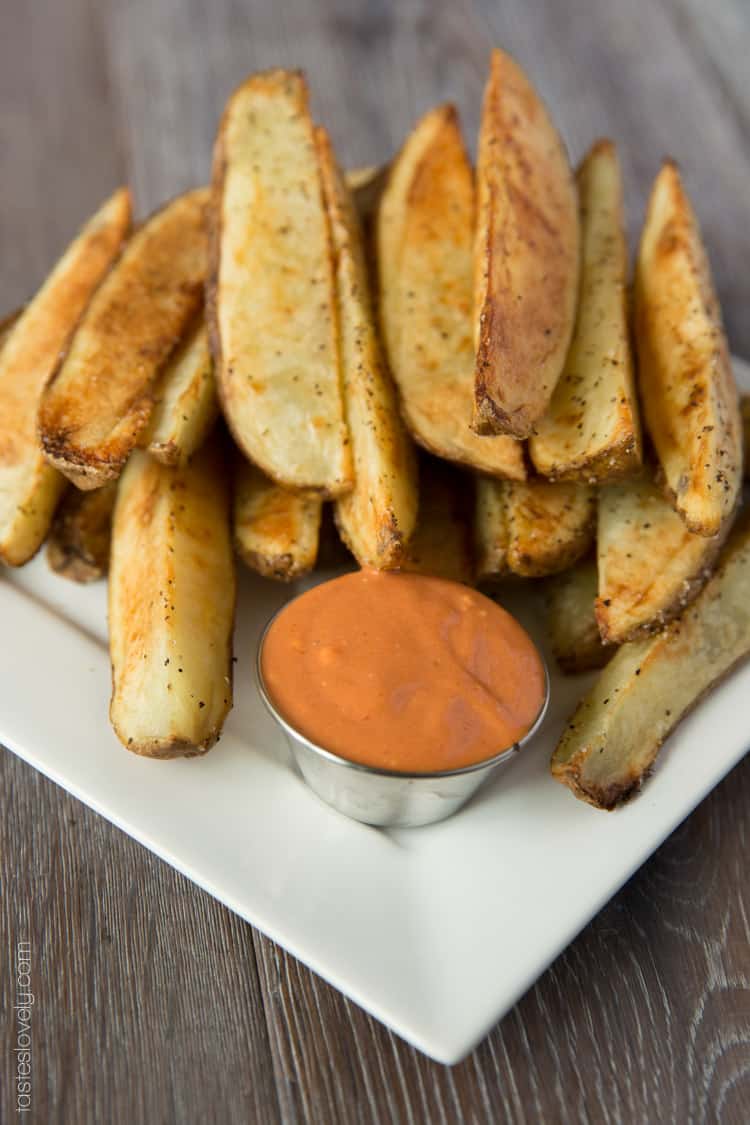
<box><xmin>208</xmin><ymin>70</ymin><xmax>353</xmax><ymax>496</ymax></box>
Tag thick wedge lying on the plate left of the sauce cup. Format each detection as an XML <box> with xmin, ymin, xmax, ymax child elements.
<box><xmin>109</xmin><ymin>440</ymin><xmax>235</xmax><ymax>758</ymax></box>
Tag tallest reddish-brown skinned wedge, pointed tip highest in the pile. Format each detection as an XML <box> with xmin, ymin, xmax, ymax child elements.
<box><xmin>473</xmin><ymin>50</ymin><xmax>579</xmax><ymax>438</ymax></box>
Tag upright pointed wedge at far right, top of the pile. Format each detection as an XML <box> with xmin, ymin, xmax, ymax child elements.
<box><xmin>635</xmin><ymin>161</ymin><xmax>742</xmax><ymax>536</ymax></box>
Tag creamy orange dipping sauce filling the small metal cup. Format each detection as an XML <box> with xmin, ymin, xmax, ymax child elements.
<box><xmin>261</xmin><ymin>570</ymin><xmax>546</xmax><ymax>773</ymax></box>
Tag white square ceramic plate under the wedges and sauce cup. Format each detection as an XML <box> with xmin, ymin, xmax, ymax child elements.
<box><xmin>0</xmin><ymin>365</ymin><xmax>750</xmax><ymax>1063</ymax></box>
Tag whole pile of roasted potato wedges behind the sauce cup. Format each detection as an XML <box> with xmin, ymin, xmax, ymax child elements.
<box><xmin>0</xmin><ymin>50</ymin><xmax>750</xmax><ymax>808</ymax></box>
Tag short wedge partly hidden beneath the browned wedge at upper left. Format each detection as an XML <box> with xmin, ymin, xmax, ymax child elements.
<box><xmin>142</xmin><ymin>315</ymin><xmax>219</xmax><ymax>465</ymax></box>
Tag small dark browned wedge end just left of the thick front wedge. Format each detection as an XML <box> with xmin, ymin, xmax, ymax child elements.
<box><xmin>47</xmin><ymin>482</ymin><xmax>117</xmax><ymax>583</ymax></box>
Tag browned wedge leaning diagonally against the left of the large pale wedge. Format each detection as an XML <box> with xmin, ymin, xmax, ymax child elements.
<box><xmin>39</xmin><ymin>188</ymin><xmax>209</xmax><ymax>488</ymax></box>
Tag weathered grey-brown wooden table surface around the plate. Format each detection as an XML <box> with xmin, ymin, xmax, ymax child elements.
<box><xmin>0</xmin><ymin>0</ymin><xmax>750</xmax><ymax>1125</ymax></box>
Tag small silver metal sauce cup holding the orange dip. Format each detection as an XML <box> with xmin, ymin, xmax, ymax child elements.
<box><xmin>255</xmin><ymin>606</ymin><xmax>550</xmax><ymax>828</ymax></box>
